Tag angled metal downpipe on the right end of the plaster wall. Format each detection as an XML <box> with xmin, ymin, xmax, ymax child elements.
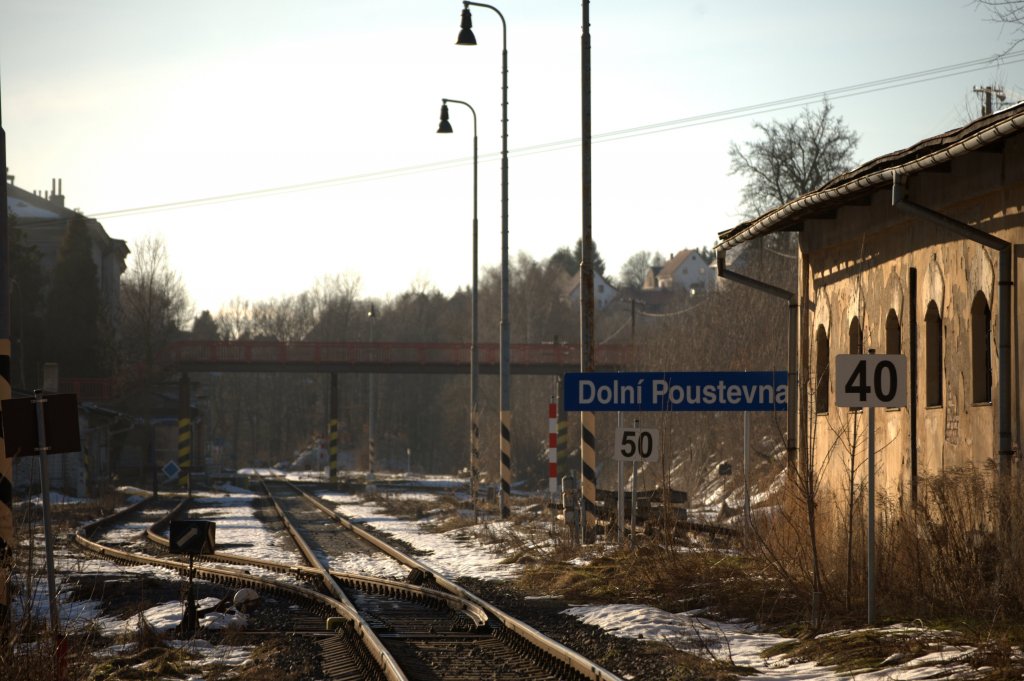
<box><xmin>892</xmin><ymin>172</ymin><xmax>1014</xmax><ymax>475</ymax></box>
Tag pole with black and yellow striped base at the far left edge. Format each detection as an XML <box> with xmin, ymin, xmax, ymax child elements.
<box><xmin>0</xmin><ymin>99</ymin><xmax>14</xmax><ymax>614</ymax></box>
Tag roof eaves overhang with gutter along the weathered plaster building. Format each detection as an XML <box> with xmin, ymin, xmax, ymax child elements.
<box><xmin>715</xmin><ymin>105</ymin><xmax>1024</xmax><ymax>251</ymax></box>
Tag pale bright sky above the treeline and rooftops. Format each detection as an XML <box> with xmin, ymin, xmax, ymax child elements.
<box><xmin>0</xmin><ymin>0</ymin><xmax>1024</xmax><ymax>313</ymax></box>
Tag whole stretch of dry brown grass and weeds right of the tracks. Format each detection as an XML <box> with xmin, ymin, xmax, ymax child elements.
<box><xmin>507</xmin><ymin>469</ymin><xmax>1024</xmax><ymax>681</ymax></box>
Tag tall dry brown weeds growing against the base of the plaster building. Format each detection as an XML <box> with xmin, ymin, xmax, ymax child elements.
<box><xmin>746</xmin><ymin>468</ymin><xmax>1024</xmax><ymax>627</ymax></box>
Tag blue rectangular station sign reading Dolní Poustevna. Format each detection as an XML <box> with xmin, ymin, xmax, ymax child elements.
<box><xmin>563</xmin><ymin>372</ymin><xmax>787</xmax><ymax>412</ymax></box>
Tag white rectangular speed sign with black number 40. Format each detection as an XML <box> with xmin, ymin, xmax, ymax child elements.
<box><xmin>836</xmin><ymin>354</ymin><xmax>906</xmax><ymax>407</ymax></box>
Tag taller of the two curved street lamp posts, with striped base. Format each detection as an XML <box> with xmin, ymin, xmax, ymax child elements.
<box><xmin>456</xmin><ymin>0</ymin><xmax>512</xmax><ymax>518</ymax></box>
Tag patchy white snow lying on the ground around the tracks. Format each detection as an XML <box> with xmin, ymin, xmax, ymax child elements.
<box><xmin>14</xmin><ymin>481</ymin><xmax>974</xmax><ymax>681</ymax></box>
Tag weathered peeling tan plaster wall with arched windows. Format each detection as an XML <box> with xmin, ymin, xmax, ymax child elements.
<box><xmin>800</xmin><ymin>135</ymin><xmax>1024</xmax><ymax>501</ymax></box>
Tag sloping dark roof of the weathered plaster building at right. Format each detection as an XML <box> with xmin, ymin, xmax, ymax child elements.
<box><xmin>716</xmin><ymin>102</ymin><xmax>1024</xmax><ymax>250</ymax></box>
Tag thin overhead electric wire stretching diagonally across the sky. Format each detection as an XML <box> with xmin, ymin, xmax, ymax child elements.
<box><xmin>79</xmin><ymin>50</ymin><xmax>1024</xmax><ymax>219</ymax></box>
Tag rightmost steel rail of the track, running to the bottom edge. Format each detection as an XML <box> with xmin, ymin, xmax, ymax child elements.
<box><xmin>275</xmin><ymin>479</ymin><xmax>623</xmax><ymax>681</ymax></box>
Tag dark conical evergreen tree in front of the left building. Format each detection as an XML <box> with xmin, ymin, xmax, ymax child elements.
<box><xmin>43</xmin><ymin>216</ymin><xmax>113</xmax><ymax>378</ymax></box>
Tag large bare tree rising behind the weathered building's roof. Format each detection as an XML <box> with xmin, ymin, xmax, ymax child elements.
<box><xmin>729</xmin><ymin>99</ymin><xmax>859</xmax><ymax>218</ymax></box>
